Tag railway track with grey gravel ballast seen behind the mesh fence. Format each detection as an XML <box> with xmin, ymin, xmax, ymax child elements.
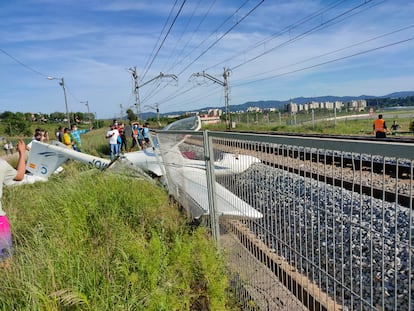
<box><xmin>175</xmin><ymin>131</ymin><xmax>414</xmax><ymax>310</ymax></box>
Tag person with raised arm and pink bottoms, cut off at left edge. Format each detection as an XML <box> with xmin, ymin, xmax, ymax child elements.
<box><xmin>0</xmin><ymin>139</ymin><xmax>26</xmax><ymax>267</ymax></box>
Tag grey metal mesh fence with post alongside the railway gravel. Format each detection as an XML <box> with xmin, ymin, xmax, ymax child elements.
<box><xmin>158</xmin><ymin>132</ymin><xmax>414</xmax><ymax>310</ymax></box>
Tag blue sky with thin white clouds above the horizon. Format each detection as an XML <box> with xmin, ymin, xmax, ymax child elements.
<box><xmin>0</xmin><ymin>0</ymin><xmax>414</xmax><ymax>118</ymax></box>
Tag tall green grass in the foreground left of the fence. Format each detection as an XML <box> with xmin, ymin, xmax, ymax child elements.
<box><xmin>0</xmin><ymin>163</ymin><xmax>233</xmax><ymax>310</ymax></box>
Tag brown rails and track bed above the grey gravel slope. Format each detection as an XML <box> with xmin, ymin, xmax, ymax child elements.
<box><xmin>187</xmin><ymin>132</ymin><xmax>414</xmax><ymax>208</ymax></box>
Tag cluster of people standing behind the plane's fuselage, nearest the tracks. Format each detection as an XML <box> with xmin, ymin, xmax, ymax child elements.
<box><xmin>105</xmin><ymin>120</ymin><xmax>150</xmax><ymax>160</ymax></box>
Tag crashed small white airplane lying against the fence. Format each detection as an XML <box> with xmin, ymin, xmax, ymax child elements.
<box><xmin>26</xmin><ymin>117</ymin><xmax>263</xmax><ymax>219</ymax></box>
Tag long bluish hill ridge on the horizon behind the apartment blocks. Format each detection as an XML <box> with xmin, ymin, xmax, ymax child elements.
<box><xmin>142</xmin><ymin>91</ymin><xmax>414</xmax><ymax>119</ymax></box>
